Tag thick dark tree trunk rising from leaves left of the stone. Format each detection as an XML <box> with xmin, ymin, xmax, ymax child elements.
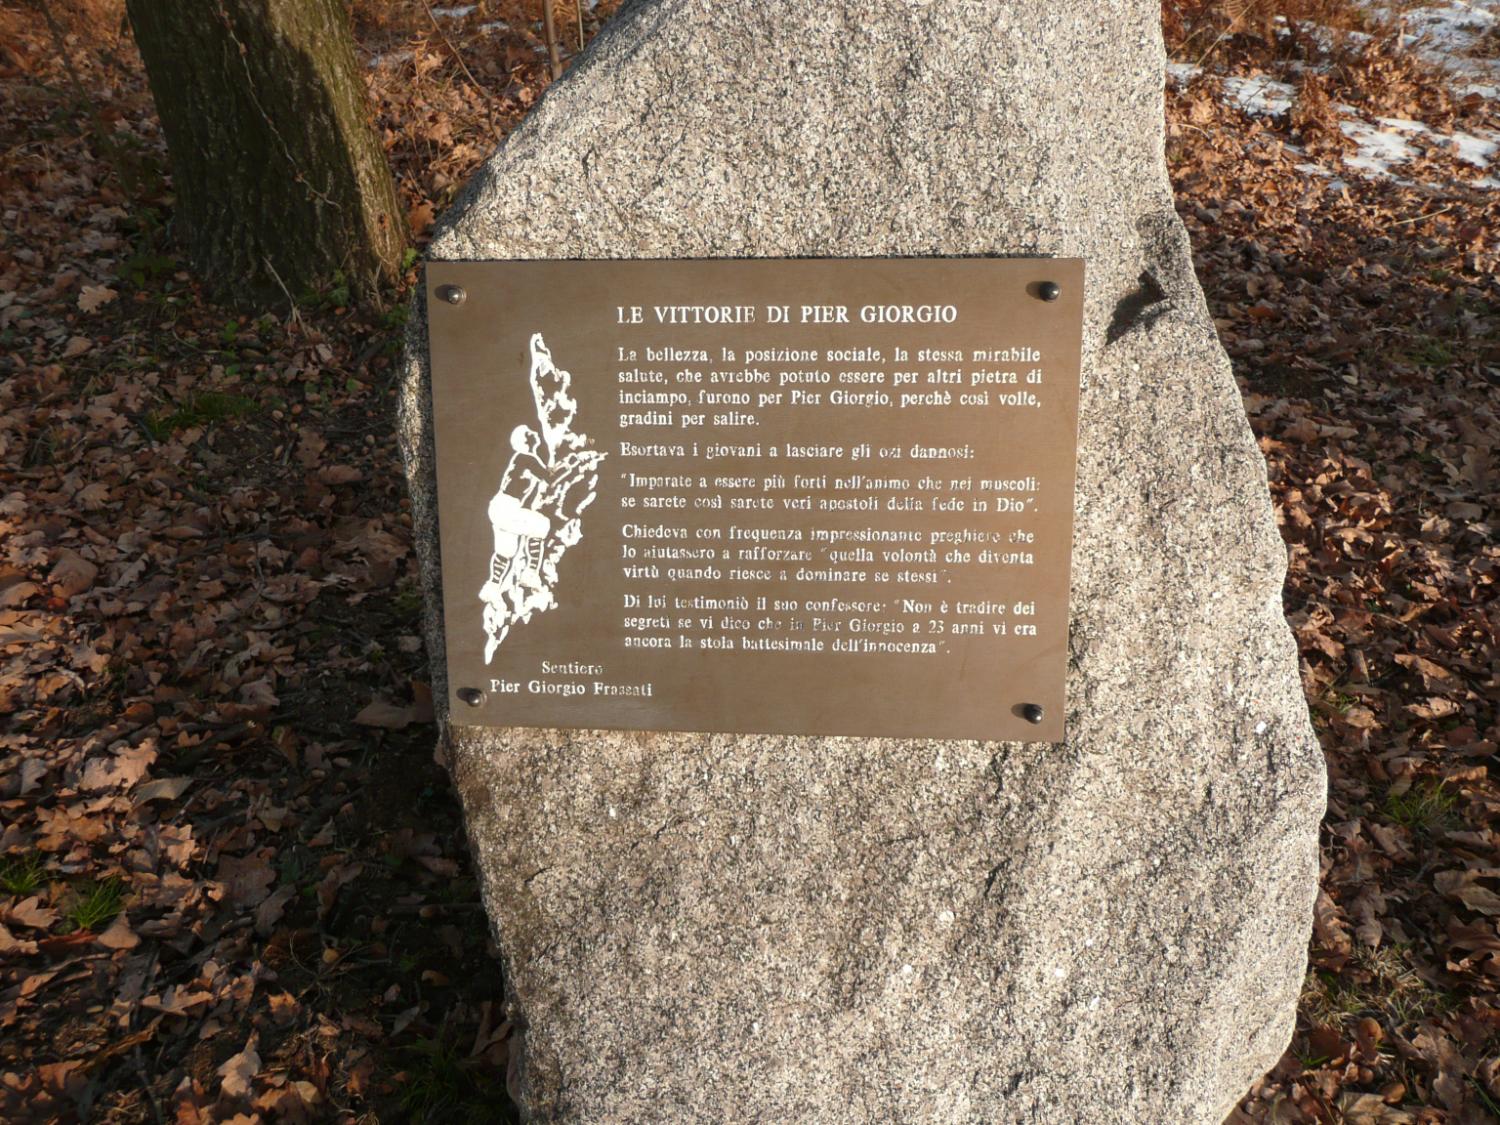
<box><xmin>126</xmin><ymin>0</ymin><xmax>407</xmax><ymax>300</ymax></box>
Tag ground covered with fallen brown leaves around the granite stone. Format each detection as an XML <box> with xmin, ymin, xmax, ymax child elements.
<box><xmin>0</xmin><ymin>0</ymin><xmax>1500</xmax><ymax>1125</ymax></box>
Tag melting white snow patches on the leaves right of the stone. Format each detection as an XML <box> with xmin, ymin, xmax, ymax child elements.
<box><xmin>1167</xmin><ymin>0</ymin><xmax>1500</xmax><ymax>189</ymax></box>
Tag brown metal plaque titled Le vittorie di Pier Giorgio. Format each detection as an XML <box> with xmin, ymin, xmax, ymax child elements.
<box><xmin>426</xmin><ymin>258</ymin><xmax>1083</xmax><ymax>741</ymax></box>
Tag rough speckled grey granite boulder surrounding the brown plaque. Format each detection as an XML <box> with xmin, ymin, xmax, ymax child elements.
<box><xmin>402</xmin><ymin>0</ymin><xmax>1325</xmax><ymax>1125</ymax></box>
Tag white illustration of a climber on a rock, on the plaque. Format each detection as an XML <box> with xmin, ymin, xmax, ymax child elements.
<box><xmin>479</xmin><ymin>332</ymin><xmax>606</xmax><ymax>665</ymax></box>
